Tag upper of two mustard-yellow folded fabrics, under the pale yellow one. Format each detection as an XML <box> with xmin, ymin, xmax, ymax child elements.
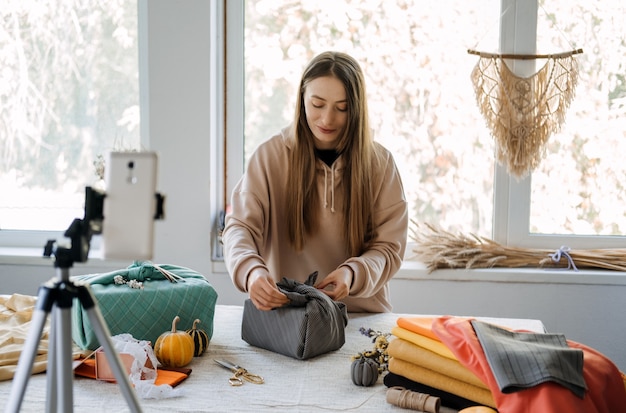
<box><xmin>387</xmin><ymin>338</ymin><xmax>489</xmax><ymax>390</ymax></box>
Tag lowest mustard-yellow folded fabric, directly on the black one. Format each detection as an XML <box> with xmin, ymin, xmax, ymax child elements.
<box><xmin>389</xmin><ymin>357</ymin><xmax>496</xmax><ymax>408</ymax></box>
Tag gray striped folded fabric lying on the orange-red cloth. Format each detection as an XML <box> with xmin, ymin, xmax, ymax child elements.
<box><xmin>472</xmin><ymin>320</ymin><xmax>587</xmax><ymax>398</ymax></box>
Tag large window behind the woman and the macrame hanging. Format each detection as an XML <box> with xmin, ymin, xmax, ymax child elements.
<box><xmin>227</xmin><ymin>0</ymin><xmax>626</xmax><ymax>248</ymax></box>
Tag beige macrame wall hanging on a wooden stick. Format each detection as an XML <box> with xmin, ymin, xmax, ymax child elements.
<box><xmin>468</xmin><ymin>32</ymin><xmax>582</xmax><ymax>178</ymax></box>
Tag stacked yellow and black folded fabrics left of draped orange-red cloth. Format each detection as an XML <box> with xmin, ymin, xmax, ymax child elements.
<box><xmin>384</xmin><ymin>317</ymin><xmax>496</xmax><ymax>409</ymax></box>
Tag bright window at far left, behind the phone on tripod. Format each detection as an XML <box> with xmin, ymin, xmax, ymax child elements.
<box><xmin>0</xmin><ymin>0</ymin><xmax>139</xmax><ymax>247</ymax></box>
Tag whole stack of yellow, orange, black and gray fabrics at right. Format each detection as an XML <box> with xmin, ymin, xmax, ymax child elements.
<box><xmin>384</xmin><ymin>317</ymin><xmax>626</xmax><ymax>413</ymax></box>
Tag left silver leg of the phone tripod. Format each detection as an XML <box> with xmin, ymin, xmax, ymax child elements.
<box><xmin>5</xmin><ymin>284</ymin><xmax>54</xmax><ymax>413</ymax></box>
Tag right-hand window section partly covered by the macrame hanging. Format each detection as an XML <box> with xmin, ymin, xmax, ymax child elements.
<box><xmin>496</xmin><ymin>2</ymin><xmax>626</xmax><ymax>248</ymax></box>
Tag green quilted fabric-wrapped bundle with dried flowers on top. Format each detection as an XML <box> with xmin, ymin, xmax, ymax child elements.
<box><xmin>72</xmin><ymin>261</ymin><xmax>218</xmax><ymax>350</ymax></box>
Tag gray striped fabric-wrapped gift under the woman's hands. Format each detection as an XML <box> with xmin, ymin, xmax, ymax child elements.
<box><xmin>241</xmin><ymin>271</ymin><xmax>348</xmax><ymax>360</ymax></box>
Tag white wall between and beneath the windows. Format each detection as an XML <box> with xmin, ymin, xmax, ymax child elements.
<box><xmin>0</xmin><ymin>0</ymin><xmax>626</xmax><ymax>370</ymax></box>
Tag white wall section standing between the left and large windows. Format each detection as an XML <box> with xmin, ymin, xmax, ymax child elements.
<box><xmin>140</xmin><ymin>0</ymin><xmax>245</xmax><ymax>304</ymax></box>
